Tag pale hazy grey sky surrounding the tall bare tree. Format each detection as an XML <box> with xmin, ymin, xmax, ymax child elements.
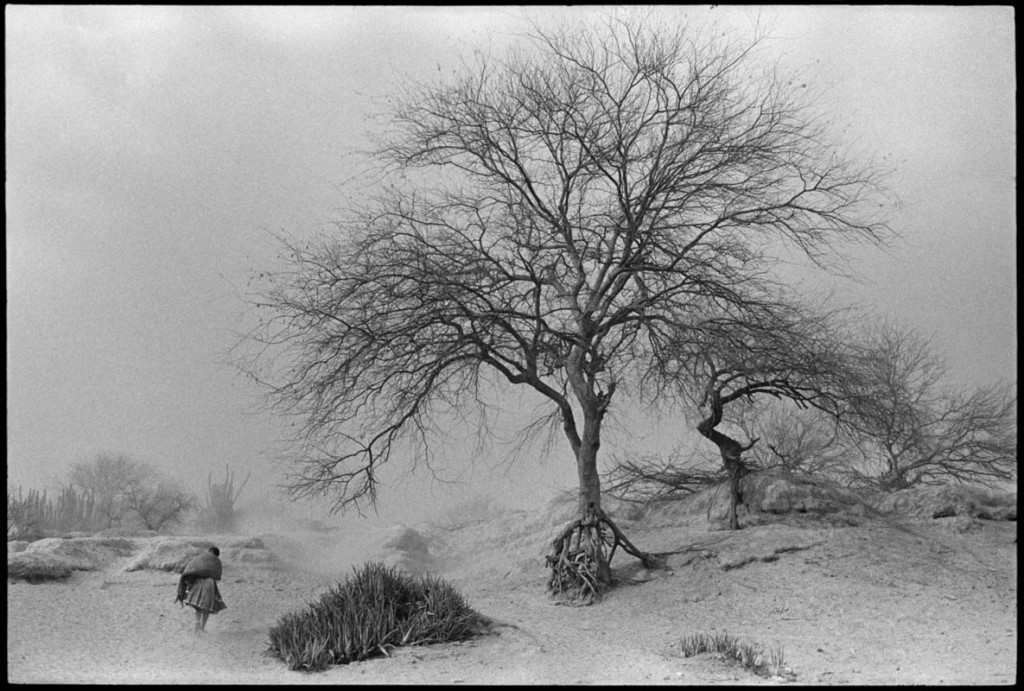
<box><xmin>4</xmin><ymin>5</ymin><xmax>1017</xmax><ymax>515</ymax></box>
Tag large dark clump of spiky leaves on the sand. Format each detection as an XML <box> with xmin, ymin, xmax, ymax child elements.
<box><xmin>269</xmin><ymin>562</ymin><xmax>484</xmax><ymax>672</ymax></box>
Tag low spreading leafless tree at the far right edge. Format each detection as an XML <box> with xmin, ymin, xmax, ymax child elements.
<box><xmin>850</xmin><ymin>321</ymin><xmax>1017</xmax><ymax>489</ymax></box>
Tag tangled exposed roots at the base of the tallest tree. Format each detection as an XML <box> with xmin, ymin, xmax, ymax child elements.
<box><xmin>547</xmin><ymin>509</ymin><xmax>658</xmax><ymax>605</ymax></box>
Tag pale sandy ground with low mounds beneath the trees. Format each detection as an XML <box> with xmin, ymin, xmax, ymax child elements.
<box><xmin>7</xmin><ymin>477</ymin><xmax>1017</xmax><ymax>685</ymax></box>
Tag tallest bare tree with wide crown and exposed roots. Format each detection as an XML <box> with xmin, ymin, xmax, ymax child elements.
<box><xmin>237</xmin><ymin>16</ymin><xmax>887</xmax><ymax>601</ymax></box>
